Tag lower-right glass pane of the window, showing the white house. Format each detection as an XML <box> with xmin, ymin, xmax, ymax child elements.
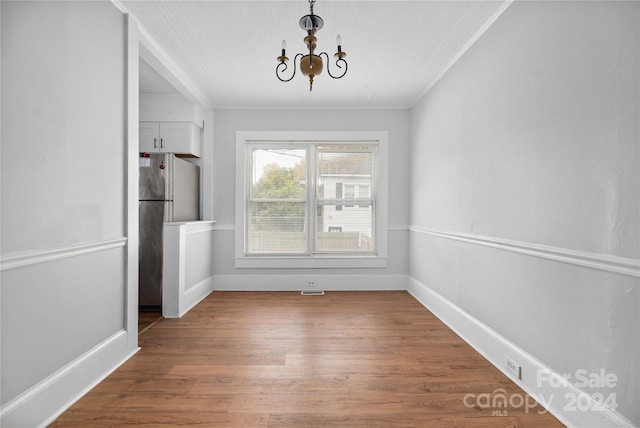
<box><xmin>316</xmin><ymin>202</ymin><xmax>375</xmax><ymax>253</ymax></box>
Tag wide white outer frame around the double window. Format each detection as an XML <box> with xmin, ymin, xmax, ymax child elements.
<box><xmin>235</xmin><ymin>131</ymin><xmax>389</xmax><ymax>268</ymax></box>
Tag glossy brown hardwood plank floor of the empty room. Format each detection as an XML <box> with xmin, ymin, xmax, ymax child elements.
<box><xmin>51</xmin><ymin>291</ymin><xmax>563</xmax><ymax>427</ymax></box>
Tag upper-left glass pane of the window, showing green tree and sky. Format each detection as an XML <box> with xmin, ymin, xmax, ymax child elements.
<box><xmin>251</xmin><ymin>149</ymin><xmax>307</xmax><ymax>199</ymax></box>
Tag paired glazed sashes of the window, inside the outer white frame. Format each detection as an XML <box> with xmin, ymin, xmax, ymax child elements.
<box><xmin>245</xmin><ymin>142</ymin><xmax>378</xmax><ymax>256</ymax></box>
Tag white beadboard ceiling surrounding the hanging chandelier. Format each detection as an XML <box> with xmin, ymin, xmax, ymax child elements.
<box><xmin>117</xmin><ymin>0</ymin><xmax>509</xmax><ymax>109</ymax></box>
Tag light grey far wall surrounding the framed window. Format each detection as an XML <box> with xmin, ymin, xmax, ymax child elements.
<box><xmin>213</xmin><ymin>110</ymin><xmax>409</xmax><ymax>289</ymax></box>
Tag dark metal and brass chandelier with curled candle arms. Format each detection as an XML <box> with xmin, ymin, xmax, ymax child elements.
<box><xmin>276</xmin><ymin>0</ymin><xmax>347</xmax><ymax>92</ymax></box>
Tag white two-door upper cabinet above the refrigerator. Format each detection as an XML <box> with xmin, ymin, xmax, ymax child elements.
<box><xmin>140</xmin><ymin>122</ymin><xmax>200</xmax><ymax>157</ymax></box>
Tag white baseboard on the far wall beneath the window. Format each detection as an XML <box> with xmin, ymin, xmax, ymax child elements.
<box><xmin>213</xmin><ymin>274</ymin><xmax>407</xmax><ymax>291</ymax></box>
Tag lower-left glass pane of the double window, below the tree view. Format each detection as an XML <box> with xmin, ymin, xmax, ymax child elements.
<box><xmin>247</xmin><ymin>202</ymin><xmax>307</xmax><ymax>253</ymax></box>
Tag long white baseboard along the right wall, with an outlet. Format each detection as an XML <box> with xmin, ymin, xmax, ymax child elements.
<box><xmin>407</xmin><ymin>278</ymin><xmax>634</xmax><ymax>428</ymax></box>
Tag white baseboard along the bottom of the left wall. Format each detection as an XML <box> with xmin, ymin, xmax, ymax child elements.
<box><xmin>0</xmin><ymin>330</ymin><xmax>138</xmax><ymax>428</ymax></box>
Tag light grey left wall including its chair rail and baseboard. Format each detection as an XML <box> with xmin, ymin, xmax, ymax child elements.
<box><xmin>1</xmin><ymin>1</ymin><xmax>137</xmax><ymax>427</ymax></box>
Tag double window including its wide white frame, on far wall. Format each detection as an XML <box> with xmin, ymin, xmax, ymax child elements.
<box><xmin>236</xmin><ymin>132</ymin><xmax>386</xmax><ymax>267</ymax></box>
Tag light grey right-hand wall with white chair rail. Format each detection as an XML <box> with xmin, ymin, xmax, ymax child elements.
<box><xmin>410</xmin><ymin>1</ymin><xmax>640</xmax><ymax>425</ymax></box>
